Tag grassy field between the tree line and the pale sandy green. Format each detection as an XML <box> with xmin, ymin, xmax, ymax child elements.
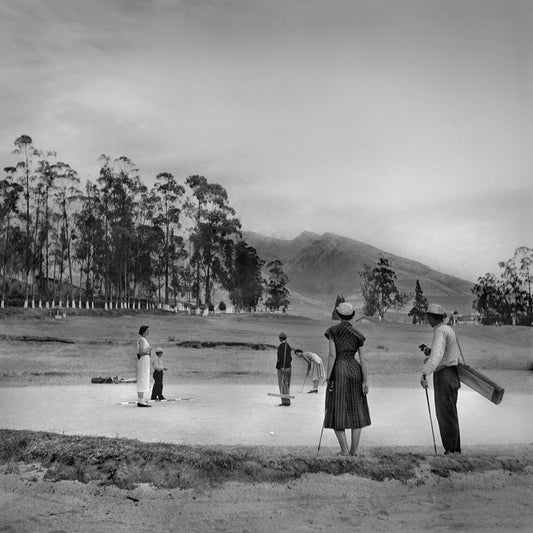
<box><xmin>0</xmin><ymin>310</ymin><xmax>533</xmax><ymax>390</ymax></box>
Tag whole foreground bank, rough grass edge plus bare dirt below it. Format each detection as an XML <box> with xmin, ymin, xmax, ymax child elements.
<box><xmin>0</xmin><ymin>430</ymin><xmax>533</xmax><ymax>533</ymax></box>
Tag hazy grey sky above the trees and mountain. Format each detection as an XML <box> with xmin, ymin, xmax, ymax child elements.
<box><xmin>0</xmin><ymin>0</ymin><xmax>533</xmax><ymax>280</ymax></box>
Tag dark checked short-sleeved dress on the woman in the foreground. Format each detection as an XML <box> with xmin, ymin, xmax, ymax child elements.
<box><xmin>324</xmin><ymin>321</ymin><xmax>371</xmax><ymax>429</ymax></box>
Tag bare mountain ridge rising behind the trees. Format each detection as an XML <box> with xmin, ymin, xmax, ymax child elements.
<box><xmin>243</xmin><ymin>231</ymin><xmax>473</xmax><ymax>313</ymax></box>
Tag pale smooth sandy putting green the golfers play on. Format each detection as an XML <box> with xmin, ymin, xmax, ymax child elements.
<box><xmin>0</xmin><ymin>383</ymin><xmax>533</xmax><ymax>449</ymax></box>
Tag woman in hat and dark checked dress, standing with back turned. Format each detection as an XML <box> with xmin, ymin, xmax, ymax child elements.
<box><xmin>324</xmin><ymin>302</ymin><xmax>370</xmax><ymax>455</ymax></box>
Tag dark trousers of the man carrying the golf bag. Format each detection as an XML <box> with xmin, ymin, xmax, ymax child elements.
<box><xmin>433</xmin><ymin>366</ymin><xmax>461</xmax><ymax>453</ymax></box>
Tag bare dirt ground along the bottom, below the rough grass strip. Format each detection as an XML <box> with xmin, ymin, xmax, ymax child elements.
<box><xmin>0</xmin><ymin>454</ymin><xmax>533</xmax><ymax>533</ymax></box>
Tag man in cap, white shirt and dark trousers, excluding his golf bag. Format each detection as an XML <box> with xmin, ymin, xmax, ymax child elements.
<box><xmin>419</xmin><ymin>304</ymin><xmax>461</xmax><ymax>455</ymax></box>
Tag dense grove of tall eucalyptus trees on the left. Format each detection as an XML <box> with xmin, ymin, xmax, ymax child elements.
<box><xmin>0</xmin><ymin>135</ymin><xmax>289</xmax><ymax>310</ymax></box>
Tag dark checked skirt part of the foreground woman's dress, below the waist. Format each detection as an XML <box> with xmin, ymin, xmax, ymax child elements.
<box><xmin>324</xmin><ymin>354</ymin><xmax>370</xmax><ymax>429</ymax></box>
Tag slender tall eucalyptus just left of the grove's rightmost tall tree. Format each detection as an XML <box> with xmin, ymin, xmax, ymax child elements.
<box><xmin>154</xmin><ymin>172</ymin><xmax>185</xmax><ymax>306</ymax></box>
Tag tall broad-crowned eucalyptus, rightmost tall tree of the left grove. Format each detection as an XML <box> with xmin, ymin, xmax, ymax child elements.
<box><xmin>185</xmin><ymin>175</ymin><xmax>241</xmax><ymax>305</ymax></box>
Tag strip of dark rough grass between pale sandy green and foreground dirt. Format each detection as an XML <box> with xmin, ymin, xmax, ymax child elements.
<box><xmin>0</xmin><ymin>429</ymin><xmax>533</xmax><ymax>489</ymax></box>
